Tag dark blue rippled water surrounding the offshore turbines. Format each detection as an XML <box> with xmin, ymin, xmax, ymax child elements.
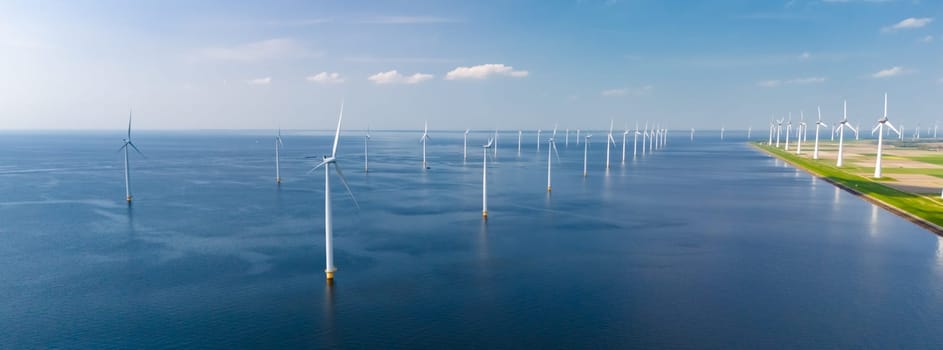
<box><xmin>0</xmin><ymin>132</ymin><xmax>943</xmax><ymax>349</ymax></box>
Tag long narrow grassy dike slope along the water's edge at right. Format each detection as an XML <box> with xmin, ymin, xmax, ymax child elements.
<box><xmin>751</xmin><ymin>142</ymin><xmax>943</xmax><ymax>235</ymax></box>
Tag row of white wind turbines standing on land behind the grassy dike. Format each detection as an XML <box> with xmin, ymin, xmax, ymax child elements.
<box><xmin>767</xmin><ymin>93</ymin><xmax>943</xmax><ymax>180</ymax></box>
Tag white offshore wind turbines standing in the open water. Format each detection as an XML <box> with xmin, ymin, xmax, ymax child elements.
<box><xmin>119</xmin><ymin>102</ymin><xmax>676</xmax><ymax>281</ymax></box>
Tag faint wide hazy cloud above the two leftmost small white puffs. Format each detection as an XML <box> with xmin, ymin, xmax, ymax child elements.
<box><xmin>193</xmin><ymin>38</ymin><xmax>321</xmax><ymax>62</ymax></box>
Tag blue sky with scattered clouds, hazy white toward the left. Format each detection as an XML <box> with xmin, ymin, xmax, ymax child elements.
<box><xmin>0</xmin><ymin>0</ymin><xmax>943</xmax><ymax>130</ymax></box>
